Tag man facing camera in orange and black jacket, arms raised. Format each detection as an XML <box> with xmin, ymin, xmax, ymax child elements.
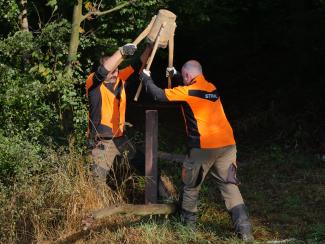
<box><xmin>86</xmin><ymin>44</ymin><xmax>152</xmax><ymax>182</ymax></box>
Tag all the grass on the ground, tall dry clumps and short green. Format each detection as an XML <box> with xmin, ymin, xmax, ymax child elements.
<box><xmin>0</xmin><ymin>142</ymin><xmax>325</xmax><ymax>243</ymax></box>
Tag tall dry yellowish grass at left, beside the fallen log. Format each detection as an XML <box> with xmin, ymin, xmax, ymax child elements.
<box><xmin>0</xmin><ymin>138</ymin><xmax>124</xmax><ymax>243</ymax></box>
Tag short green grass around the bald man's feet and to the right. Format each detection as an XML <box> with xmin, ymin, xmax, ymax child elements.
<box><xmin>85</xmin><ymin>147</ymin><xmax>325</xmax><ymax>243</ymax></box>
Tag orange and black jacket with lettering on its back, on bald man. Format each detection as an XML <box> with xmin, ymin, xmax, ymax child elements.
<box><xmin>141</xmin><ymin>74</ymin><xmax>235</xmax><ymax>148</ymax></box>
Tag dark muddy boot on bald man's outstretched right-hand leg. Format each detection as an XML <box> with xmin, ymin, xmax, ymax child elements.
<box><xmin>230</xmin><ymin>204</ymin><xmax>254</xmax><ymax>242</ymax></box>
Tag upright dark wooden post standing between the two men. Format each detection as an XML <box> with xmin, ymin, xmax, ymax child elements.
<box><xmin>145</xmin><ymin>110</ymin><xmax>158</xmax><ymax>204</ymax></box>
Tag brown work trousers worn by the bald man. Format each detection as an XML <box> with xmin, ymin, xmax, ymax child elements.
<box><xmin>182</xmin><ymin>145</ymin><xmax>244</xmax><ymax>213</ymax></box>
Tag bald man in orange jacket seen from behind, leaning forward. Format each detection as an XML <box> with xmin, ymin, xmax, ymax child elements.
<box><xmin>140</xmin><ymin>60</ymin><xmax>254</xmax><ymax>241</ymax></box>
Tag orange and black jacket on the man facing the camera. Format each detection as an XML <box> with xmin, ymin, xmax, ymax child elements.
<box><xmin>86</xmin><ymin>59</ymin><xmax>141</xmax><ymax>139</ymax></box>
